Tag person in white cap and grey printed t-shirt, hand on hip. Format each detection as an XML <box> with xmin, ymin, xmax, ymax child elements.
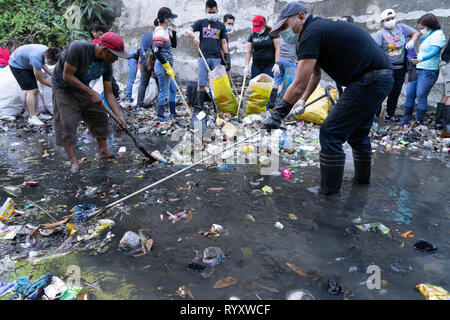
<box><xmin>372</xmin><ymin>9</ymin><xmax>419</xmax><ymax>122</ymax></box>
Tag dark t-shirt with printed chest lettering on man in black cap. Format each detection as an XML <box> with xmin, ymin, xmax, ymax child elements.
<box><xmin>192</xmin><ymin>19</ymin><xmax>227</xmax><ymax>58</ymax></box>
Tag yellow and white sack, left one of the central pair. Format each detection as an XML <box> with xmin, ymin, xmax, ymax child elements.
<box><xmin>209</xmin><ymin>65</ymin><xmax>238</xmax><ymax>116</ymax></box>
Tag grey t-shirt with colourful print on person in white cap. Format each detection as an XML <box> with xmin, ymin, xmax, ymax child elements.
<box><xmin>372</xmin><ymin>23</ymin><xmax>414</xmax><ymax>69</ymax></box>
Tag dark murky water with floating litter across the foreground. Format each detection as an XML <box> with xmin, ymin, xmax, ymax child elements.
<box><xmin>0</xmin><ymin>125</ymin><xmax>450</xmax><ymax>300</ymax></box>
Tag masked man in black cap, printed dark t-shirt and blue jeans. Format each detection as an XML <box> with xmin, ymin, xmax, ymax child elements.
<box><xmin>186</xmin><ymin>0</ymin><xmax>231</xmax><ymax>114</ymax></box>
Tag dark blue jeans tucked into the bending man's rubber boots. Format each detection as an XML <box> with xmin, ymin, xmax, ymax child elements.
<box><xmin>320</xmin><ymin>75</ymin><xmax>394</xmax><ymax>155</ymax></box>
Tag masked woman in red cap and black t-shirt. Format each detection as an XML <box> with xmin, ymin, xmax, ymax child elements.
<box><xmin>244</xmin><ymin>16</ymin><xmax>280</xmax><ymax>110</ymax></box>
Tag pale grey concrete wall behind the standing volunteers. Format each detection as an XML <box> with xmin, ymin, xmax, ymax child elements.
<box><xmin>110</xmin><ymin>0</ymin><xmax>450</xmax><ymax>104</ymax></box>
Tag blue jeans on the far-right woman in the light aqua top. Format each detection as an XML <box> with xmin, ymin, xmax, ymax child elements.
<box><xmin>405</xmin><ymin>69</ymin><xmax>439</xmax><ymax>111</ymax></box>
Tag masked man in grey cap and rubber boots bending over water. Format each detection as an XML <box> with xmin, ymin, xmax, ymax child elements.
<box><xmin>262</xmin><ymin>2</ymin><xmax>394</xmax><ymax>195</ymax></box>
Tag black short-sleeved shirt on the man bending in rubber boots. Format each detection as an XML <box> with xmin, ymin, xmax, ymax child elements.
<box><xmin>298</xmin><ymin>16</ymin><xmax>392</xmax><ymax>86</ymax></box>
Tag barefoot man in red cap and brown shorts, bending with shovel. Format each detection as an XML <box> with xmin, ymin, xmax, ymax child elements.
<box><xmin>52</xmin><ymin>32</ymin><xmax>128</xmax><ymax>172</ymax></box>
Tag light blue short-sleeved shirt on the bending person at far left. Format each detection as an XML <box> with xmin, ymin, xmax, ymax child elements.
<box><xmin>9</xmin><ymin>44</ymin><xmax>48</xmax><ymax>70</ymax></box>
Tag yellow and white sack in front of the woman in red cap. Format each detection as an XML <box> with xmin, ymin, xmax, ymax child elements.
<box><xmin>244</xmin><ymin>73</ymin><xmax>273</xmax><ymax>117</ymax></box>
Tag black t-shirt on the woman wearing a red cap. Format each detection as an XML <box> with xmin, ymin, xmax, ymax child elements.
<box><xmin>248</xmin><ymin>30</ymin><xmax>279</xmax><ymax>67</ymax></box>
